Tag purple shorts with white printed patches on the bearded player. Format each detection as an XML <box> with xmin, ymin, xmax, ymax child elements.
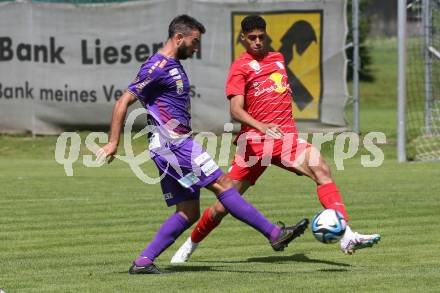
<box><xmin>150</xmin><ymin>138</ymin><xmax>223</xmax><ymax>206</ymax></box>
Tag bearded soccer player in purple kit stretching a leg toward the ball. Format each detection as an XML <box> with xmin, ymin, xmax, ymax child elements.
<box><xmin>97</xmin><ymin>15</ymin><xmax>308</xmax><ymax>274</ymax></box>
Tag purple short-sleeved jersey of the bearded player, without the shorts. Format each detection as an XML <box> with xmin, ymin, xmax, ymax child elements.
<box><xmin>128</xmin><ymin>53</ymin><xmax>191</xmax><ymax>135</ymax></box>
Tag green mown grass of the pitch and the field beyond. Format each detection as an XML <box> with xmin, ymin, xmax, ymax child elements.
<box><xmin>0</xmin><ymin>41</ymin><xmax>440</xmax><ymax>293</ymax></box>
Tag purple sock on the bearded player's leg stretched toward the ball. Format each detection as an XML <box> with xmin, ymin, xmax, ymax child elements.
<box><xmin>218</xmin><ymin>188</ymin><xmax>281</xmax><ymax>241</ymax></box>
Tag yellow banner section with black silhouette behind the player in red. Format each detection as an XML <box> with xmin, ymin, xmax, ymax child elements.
<box><xmin>232</xmin><ymin>10</ymin><xmax>323</xmax><ymax>120</ymax></box>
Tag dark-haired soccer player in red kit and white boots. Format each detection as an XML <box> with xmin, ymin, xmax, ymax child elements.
<box><xmin>171</xmin><ymin>15</ymin><xmax>380</xmax><ymax>263</ymax></box>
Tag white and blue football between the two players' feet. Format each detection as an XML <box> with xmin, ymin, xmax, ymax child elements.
<box><xmin>312</xmin><ymin>209</ymin><xmax>347</xmax><ymax>243</ymax></box>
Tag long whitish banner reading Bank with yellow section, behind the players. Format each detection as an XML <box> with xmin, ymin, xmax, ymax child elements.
<box><xmin>0</xmin><ymin>0</ymin><xmax>347</xmax><ymax>134</ymax></box>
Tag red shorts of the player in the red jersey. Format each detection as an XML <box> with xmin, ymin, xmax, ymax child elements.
<box><xmin>228</xmin><ymin>136</ymin><xmax>311</xmax><ymax>185</ymax></box>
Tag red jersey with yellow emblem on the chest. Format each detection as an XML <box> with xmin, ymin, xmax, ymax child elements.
<box><xmin>226</xmin><ymin>52</ymin><xmax>297</xmax><ymax>138</ymax></box>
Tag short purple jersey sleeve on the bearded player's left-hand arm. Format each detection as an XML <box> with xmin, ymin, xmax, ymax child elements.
<box><xmin>127</xmin><ymin>62</ymin><xmax>163</xmax><ymax>103</ymax></box>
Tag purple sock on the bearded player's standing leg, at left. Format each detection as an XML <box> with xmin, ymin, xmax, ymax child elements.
<box><xmin>135</xmin><ymin>213</ymin><xmax>191</xmax><ymax>266</ymax></box>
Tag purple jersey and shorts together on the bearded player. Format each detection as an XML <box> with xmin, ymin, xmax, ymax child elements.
<box><xmin>128</xmin><ymin>53</ymin><xmax>223</xmax><ymax>205</ymax></box>
